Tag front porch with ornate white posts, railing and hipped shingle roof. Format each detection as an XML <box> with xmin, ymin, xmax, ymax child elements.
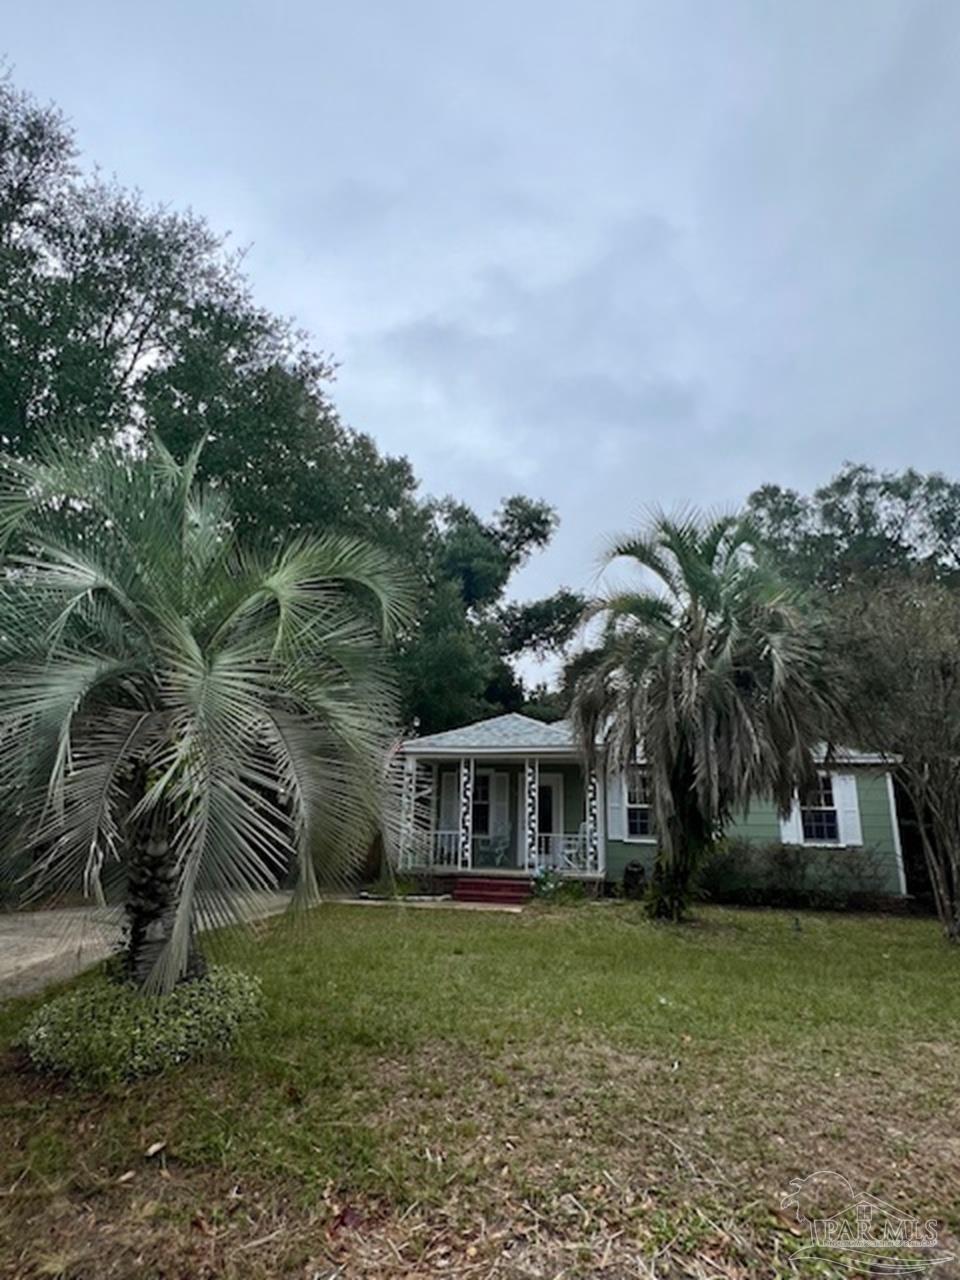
<box><xmin>398</xmin><ymin>716</ymin><xmax>604</xmax><ymax>879</ymax></box>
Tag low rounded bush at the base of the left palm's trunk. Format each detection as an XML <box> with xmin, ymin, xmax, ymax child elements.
<box><xmin>19</xmin><ymin>968</ymin><xmax>260</xmax><ymax>1085</ymax></box>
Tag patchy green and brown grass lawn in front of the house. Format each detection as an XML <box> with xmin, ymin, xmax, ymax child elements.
<box><xmin>0</xmin><ymin>904</ymin><xmax>960</xmax><ymax>1280</ymax></box>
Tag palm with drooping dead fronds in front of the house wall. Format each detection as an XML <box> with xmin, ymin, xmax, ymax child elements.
<box><xmin>572</xmin><ymin>513</ymin><xmax>829</xmax><ymax>920</ymax></box>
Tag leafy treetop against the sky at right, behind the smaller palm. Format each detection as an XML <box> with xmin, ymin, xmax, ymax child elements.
<box><xmin>748</xmin><ymin>462</ymin><xmax>960</xmax><ymax>590</ymax></box>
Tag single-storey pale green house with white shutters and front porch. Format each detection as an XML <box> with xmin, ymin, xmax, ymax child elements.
<box><xmin>399</xmin><ymin>714</ymin><xmax>906</xmax><ymax>897</ymax></box>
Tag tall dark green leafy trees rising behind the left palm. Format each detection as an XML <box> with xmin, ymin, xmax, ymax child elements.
<box><xmin>0</xmin><ymin>83</ymin><xmax>570</xmax><ymax>731</ymax></box>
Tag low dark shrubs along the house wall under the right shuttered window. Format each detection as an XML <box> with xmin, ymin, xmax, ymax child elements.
<box><xmin>696</xmin><ymin>840</ymin><xmax>888</xmax><ymax>910</ymax></box>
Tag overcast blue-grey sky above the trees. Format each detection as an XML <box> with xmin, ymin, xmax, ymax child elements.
<box><xmin>7</xmin><ymin>0</ymin><xmax>960</xmax><ymax>619</ymax></box>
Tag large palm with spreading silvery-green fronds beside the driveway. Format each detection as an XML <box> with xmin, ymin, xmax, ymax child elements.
<box><xmin>0</xmin><ymin>438</ymin><xmax>407</xmax><ymax>991</ymax></box>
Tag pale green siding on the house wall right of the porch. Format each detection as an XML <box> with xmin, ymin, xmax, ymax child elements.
<box><xmin>607</xmin><ymin>768</ymin><xmax>902</xmax><ymax>895</ymax></box>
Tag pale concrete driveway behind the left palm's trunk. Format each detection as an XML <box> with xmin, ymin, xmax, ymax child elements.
<box><xmin>0</xmin><ymin>893</ymin><xmax>291</xmax><ymax>1001</ymax></box>
